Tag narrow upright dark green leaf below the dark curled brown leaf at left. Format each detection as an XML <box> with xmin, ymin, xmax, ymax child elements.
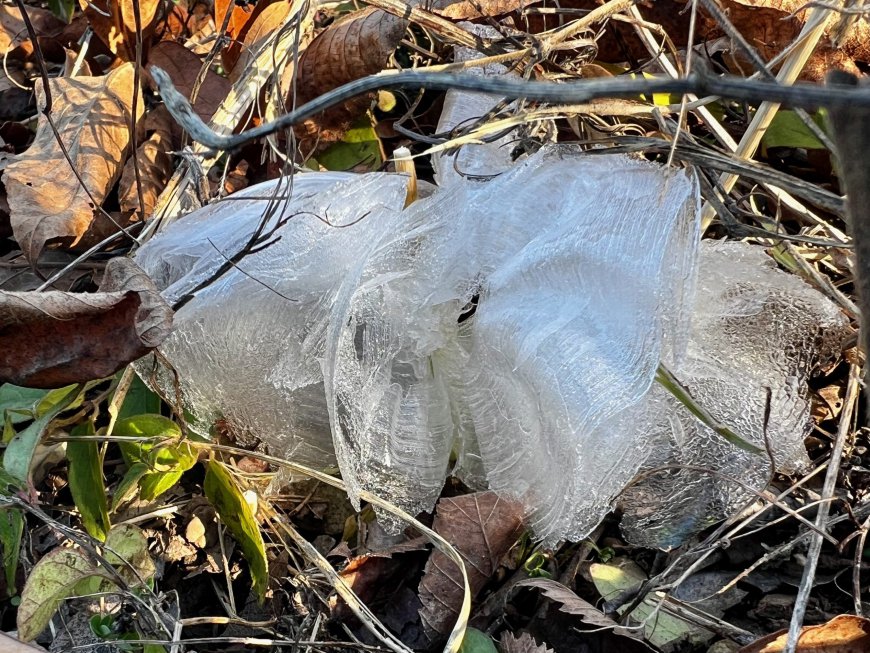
<box><xmin>66</xmin><ymin>421</ymin><xmax>111</xmax><ymax>542</ymax></box>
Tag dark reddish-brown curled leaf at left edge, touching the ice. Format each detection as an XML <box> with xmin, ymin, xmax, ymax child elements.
<box><xmin>0</xmin><ymin>257</ymin><xmax>172</xmax><ymax>388</ymax></box>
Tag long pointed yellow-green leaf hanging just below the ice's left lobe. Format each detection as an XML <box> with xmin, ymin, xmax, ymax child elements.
<box><xmin>203</xmin><ymin>460</ymin><xmax>269</xmax><ymax>603</ymax></box>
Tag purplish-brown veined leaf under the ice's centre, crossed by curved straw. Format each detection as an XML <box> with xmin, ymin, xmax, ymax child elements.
<box><xmin>419</xmin><ymin>492</ymin><xmax>522</xmax><ymax>639</ymax></box>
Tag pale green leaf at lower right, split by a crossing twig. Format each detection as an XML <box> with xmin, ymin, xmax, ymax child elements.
<box><xmin>589</xmin><ymin>559</ymin><xmax>703</xmax><ymax>648</ymax></box>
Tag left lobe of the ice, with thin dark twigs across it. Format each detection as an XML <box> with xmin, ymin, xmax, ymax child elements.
<box><xmin>136</xmin><ymin>173</ymin><xmax>406</xmax><ymax>467</ymax></box>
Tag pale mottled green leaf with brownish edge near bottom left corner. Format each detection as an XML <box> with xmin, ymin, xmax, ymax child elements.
<box><xmin>18</xmin><ymin>548</ymin><xmax>105</xmax><ymax>642</ymax></box>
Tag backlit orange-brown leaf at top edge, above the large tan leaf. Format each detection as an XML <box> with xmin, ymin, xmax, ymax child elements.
<box><xmin>79</xmin><ymin>0</ymin><xmax>161</xmax><ymax>61</ymax></box>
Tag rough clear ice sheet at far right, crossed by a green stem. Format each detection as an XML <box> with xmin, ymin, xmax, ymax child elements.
<box><xmin>621</xmin><ymin>241</ymin><xmax>850</xmax><ymax>548</ymax></box>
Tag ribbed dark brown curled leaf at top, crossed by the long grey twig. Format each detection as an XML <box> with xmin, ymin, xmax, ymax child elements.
<box><xmin>287</xmin><ymin>7</ymin><xmax>408</xmax><ymax>154</ymax></box>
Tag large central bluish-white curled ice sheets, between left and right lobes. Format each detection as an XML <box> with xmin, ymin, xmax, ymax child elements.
<box><xmin>324</xmin><ymin>148</ymin><xmax>697</xmax><ymax>537</ymax></box>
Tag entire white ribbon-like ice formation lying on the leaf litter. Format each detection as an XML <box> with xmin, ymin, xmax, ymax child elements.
<box><xmin>137</xmin><ymin>147</ymin><xmax>848</xmax><ymax>546</ymax></box>
